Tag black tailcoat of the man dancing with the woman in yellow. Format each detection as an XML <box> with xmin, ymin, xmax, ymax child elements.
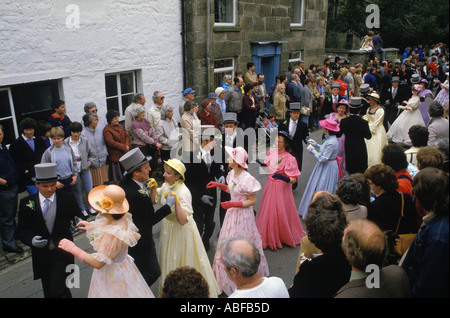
<box><xmin>119</xmin><ymin>175</ymin><xmax>171</xmax><ymax>253</ymax></box>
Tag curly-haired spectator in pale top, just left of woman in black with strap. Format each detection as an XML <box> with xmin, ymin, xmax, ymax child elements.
<box><xmin>336</xmin><ymin>177</ymin><xmax>367</xmax><ymax>221</ymax></box>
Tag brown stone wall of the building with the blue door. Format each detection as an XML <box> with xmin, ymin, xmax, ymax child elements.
<box><xmin>184</xmin><ymin>0</ymin><xmax>328</xmax><ymax>100</ymax></box>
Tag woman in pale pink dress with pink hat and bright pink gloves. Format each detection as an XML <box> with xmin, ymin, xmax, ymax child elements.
<box><xmin>206</xmin><ymin>146</ymin><xmax>269</xmax><ymax>295</ymax></box>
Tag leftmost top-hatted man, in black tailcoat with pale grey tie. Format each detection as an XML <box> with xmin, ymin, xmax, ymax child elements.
<box><xmin>16</xmin><ymin>163</ymin><xmax>82</xmax><ymax>298</ymax></box>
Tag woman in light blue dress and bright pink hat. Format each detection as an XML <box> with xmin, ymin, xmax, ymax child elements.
<box><xmin>298</xmin><ymin>119</ymin><xmax>341</xmax><ymax>219</ymax></box>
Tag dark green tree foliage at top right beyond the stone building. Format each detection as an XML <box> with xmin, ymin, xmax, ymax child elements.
<box><xmin>327</xmin><ymin>0</ymin><xmax>449</xmax><ymax>48</ymax></box>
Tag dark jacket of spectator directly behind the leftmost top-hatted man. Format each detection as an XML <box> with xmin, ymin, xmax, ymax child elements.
<box><xmin>9</xmin><ymin>136</ymin><xmax>47</xmax><ymax>190</ymax></box>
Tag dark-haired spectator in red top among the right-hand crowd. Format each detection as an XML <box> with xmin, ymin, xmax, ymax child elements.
<box><xmin>381</xmin><ymin>144</ymin><xmax>413</xmax><ymax>198</ymax></box>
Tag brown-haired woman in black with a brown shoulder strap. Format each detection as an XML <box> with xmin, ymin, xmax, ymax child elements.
<box><xmin>364</xmin><ymin>164</ymin><xmax>418</xmax><ymax>234</ymax></box>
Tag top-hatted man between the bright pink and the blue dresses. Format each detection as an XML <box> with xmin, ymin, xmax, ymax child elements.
<box><xmin>278</xmin><ymin>103</ymin><xmax>309</xmax><ymax>190</ymax></box>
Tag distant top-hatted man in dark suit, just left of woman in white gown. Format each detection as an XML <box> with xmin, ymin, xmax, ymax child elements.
<box><xmin>381</xmin><ymin>76</ymin><xmax>406</xmax><ymax>131</ymax></box>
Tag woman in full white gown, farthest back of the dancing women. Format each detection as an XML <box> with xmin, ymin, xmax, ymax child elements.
<box><xmin>387</xmin><ymin>85</ymin><xmax>426</xmax><ymax>146</ymax></box>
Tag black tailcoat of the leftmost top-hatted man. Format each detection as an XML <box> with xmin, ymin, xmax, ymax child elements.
<box><xmin>16</xmin><ymin>191</ymin><xmax>82</xmax><ymax>279</ymax></box>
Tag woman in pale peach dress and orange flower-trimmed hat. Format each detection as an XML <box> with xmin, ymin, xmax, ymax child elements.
<box><xmin>58</xmin><ymin>185</ymin><xmax>154</xmax><ymax>298</ymax></box>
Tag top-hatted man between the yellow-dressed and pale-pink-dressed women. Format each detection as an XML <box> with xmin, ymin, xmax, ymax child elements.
<box><xmin>184</xmin><ymin>125</ymin><xmax>224</xmax><ymax>251</ymax></box>
